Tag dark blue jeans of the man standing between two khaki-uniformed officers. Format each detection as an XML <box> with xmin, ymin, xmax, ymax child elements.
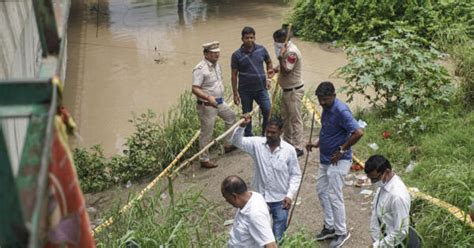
<box><xmin>239</xmin><ymin>90</ymin><xmax>271</xmax><ymax>137</ymax></box>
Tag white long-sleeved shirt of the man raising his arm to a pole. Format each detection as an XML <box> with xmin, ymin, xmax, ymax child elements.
<box><xmin>232</xmin><ymin>127</ymin><xmax>301</xmax><ymax>202</ymax></box>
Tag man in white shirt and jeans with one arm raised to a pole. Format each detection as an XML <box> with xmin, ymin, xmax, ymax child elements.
<box><xmin>231</xmin><ymin>115</ymin><xmax>301</xmax><ymax>241</ymax></box>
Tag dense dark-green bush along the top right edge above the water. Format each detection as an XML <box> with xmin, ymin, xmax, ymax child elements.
<box><xmin>289</xmin><ymin>0</ymin><xmax>474</xmax><ymax>42</ymax></box>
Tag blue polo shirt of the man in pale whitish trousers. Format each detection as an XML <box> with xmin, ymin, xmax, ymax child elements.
<box><xmin>319</xmin><ymin>99</ymin><xmax>359</xmax><ymax>164</ymax></box>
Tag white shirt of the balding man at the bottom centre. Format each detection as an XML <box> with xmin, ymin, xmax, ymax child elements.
<box><xmin>227</xmin><ymin>192</ymin><xmax>275</xmax><ymax>248</ymax></box>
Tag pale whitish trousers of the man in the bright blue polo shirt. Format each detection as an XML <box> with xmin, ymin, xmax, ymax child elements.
<box><xmin>316</xmin><ymin>160</ymin><xmax>352</xmax><ymax>235</ymax></box>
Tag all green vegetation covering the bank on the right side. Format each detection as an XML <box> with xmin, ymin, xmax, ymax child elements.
<box><xmin>289</xmin><ymin>0</ymin><xmax>474</xmax><ymax>247</ymax></box>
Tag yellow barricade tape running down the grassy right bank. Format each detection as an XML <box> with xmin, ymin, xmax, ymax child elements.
<box><xmin>303</xmin><ymin>96</ymin><xmax>474</xmax><ymax>228</ymax></box>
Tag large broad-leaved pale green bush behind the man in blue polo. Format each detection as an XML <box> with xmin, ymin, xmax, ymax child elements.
<box><xmin>338</xmin><ymin>28</ymin><xmax>453</xmax><ymax>113</ymax></box>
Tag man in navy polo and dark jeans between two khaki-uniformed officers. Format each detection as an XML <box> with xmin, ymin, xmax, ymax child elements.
<box><xmin>231</xmin><ymin>27</ymin><xmax>274</xmax><ymax>137</ymax></box>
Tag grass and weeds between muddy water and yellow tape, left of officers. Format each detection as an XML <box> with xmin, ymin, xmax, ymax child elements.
<box><xmin>74</xmin><ymin>92</ymin><xmax>205</xmax><ymax>192</ymax></box>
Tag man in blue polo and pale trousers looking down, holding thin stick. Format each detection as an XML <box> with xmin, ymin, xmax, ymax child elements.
<box><xmin>306</xmin><ymin>81</ymin><xmax>363</xmax><ymax>247</ymax></box>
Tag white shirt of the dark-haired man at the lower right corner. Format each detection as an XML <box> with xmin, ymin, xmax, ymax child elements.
<box><xmin>370</xmin><ymin>175</ymin><xmax>411</xmax><ymax>247</ymax></box>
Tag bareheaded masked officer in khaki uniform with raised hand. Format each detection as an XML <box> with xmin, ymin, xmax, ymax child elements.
<box><xmin>273</xmin><ymin>28</ymin><xmax>304</xmax><ymax>157</ymax></box>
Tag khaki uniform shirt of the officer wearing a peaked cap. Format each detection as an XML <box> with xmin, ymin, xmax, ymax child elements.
<box><xmin>193</xmin><ymin>59</ymin><xmax>224</xmax><ymax>101</ymax></box>
